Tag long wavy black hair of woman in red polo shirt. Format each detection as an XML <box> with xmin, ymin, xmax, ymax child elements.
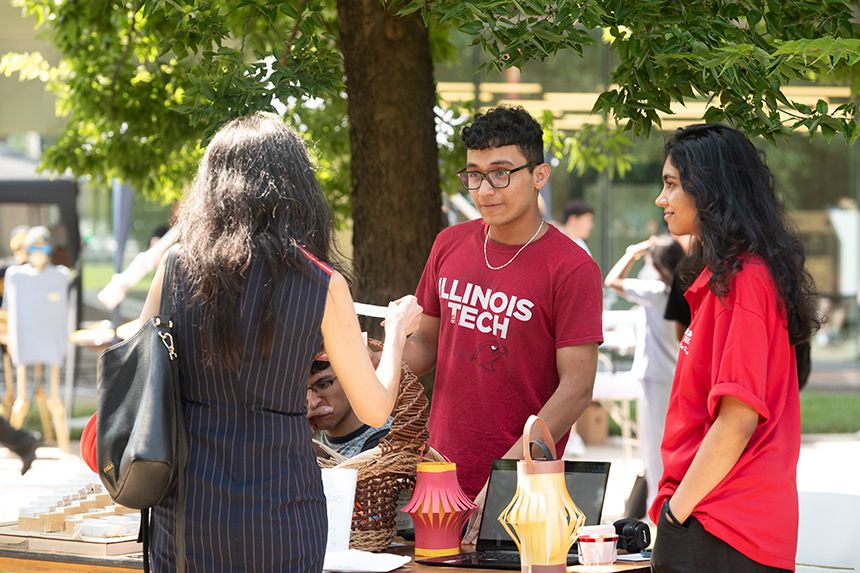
<box><xmin>666</xmin><ymin>124</ymin><xmax>820</xmax><ymax>344</ymax></box>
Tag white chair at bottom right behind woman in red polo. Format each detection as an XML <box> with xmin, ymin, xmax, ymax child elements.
<box><xmin>795</xmin><ymin>491</ymin><xmax>860</xmax><ymax>573</ymax></box>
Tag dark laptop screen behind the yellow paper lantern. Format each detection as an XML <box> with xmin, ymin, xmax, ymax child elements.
<box><xmin>475</xmin><ymin>460</ymin><xmax>609</xmax><ymax>551</ymax></box>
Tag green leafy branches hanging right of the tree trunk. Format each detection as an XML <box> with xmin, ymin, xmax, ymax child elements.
<box><xmin>404</xmin><ymin>0</ymin><xmax>860</xmax><ymax>142</ymax></box>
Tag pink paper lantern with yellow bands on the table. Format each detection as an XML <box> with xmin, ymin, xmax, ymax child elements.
<box><xmin>402</xmin><ymin>462</ymin><xmax>477</xmax><ymax>558</ymax></box>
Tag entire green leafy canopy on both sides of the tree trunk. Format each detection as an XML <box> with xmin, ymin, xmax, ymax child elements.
<box><xmin>0</xmin><ymin>0</ymin><xmax>860</xmax><ymax>206</ymax></box>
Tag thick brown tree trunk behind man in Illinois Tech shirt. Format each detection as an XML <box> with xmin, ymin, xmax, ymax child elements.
<box><xmin>337</xmin><ymin>0</ymin><xmax>442</xmax><ymax>330</ymax></box>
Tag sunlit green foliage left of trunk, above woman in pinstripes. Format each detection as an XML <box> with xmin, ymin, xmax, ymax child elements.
<box><xmin>0</xmin><ymin>0</ymin><xmax>343</xmax><ymax>203</ymax></box>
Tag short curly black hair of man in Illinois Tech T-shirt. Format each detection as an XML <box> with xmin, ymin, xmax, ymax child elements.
<box><xmin>460</xmin><ymin>106</ymin><xmax>544</xmax><ymax>163</ymax></box>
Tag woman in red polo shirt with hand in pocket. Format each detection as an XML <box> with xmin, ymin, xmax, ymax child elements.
<box><xmin>650</xmin><ymin>125</ymin><xmax>819</xmax><ymax>573</ymax></box>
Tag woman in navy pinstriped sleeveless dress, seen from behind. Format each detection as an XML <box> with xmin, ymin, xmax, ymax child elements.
<box><xmin>135</xmin><ymin>114</ymin><xmax>421</xmax><ymax>572</ymax></box>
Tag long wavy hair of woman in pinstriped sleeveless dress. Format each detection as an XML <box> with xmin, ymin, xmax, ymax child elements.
<box><xmin>179</xmin><ymin>113</ymin><xmax>340</xmax><ymax>369</ymax></box>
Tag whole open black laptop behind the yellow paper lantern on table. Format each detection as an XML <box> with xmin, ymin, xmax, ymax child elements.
<box><xmin>416</xmin><ymin>460</ymin><xmax>609</xmax><ymax>570</ymax></box>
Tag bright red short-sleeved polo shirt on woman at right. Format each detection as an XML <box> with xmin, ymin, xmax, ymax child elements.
<box><xmin>650</xmin><ymin>257</ymin><xmax>800</xmax><ymax>570</ymax></box>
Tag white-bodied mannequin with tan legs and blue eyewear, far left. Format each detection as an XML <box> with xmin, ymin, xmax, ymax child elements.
<box><xmin>4</xmin><ymin>227</ymin><xmax>69</xmax><ymax>451</ymax></box>
